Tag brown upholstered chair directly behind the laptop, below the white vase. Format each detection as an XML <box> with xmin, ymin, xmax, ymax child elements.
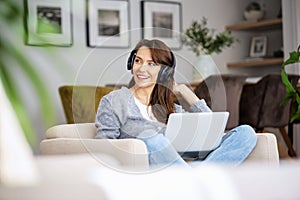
<box><xmin>194</xmin><ymin>74</ymin><xmax>246</xmax><ymax>130</ymax></box>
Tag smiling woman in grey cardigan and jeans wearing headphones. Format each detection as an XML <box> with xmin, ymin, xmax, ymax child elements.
<box><xmin>96</xmin><ymin>40</ymin><xmax>256</xmax><ymax>165</ymax></box>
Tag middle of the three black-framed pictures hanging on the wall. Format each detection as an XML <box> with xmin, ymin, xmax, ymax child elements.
<box><xmin>87</xmin><ymin>0</ymin><xmax>129</xmax><ymax>48</ymax></box>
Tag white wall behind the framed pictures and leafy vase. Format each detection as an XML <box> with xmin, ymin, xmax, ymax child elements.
<box><xmin>7</xmin><ymin>0</ymin><xmax>286</xmax><ymax>151</ymax></box>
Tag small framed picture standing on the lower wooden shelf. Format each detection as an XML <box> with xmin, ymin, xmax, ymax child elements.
<box><xmin>250</xmin><ymin>36</ymin><xmax>267</xmax><ymax>57</ymax></box>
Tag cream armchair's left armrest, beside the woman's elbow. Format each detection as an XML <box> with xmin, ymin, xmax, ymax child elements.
<box><xmin>40</xmin><ymin>138</ymin><xmax>149</xmax><ymax>168</ymax></box>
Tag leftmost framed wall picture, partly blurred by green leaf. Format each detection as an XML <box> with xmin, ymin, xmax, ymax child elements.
<box><xmin>24</xmin><ymin>0</ymin><xmax>73</xmax><ymax>46</ymax></box>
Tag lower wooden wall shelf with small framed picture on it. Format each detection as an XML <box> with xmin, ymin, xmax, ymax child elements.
<box><xmin>227</xmin><ymin>58</ymin><xmax>283</xmax><ymax>68</ymax></box>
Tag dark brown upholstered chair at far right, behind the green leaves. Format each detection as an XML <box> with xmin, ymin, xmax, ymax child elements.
<box><xmin>240</xmin><ymin>74</ymin><xmax>299</xmax><ymax>157</ymax></box>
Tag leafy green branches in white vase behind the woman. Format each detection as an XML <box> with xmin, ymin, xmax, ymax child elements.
<box><xmin>182</xmin><ymin>17</ymin><xmax>237</xmax><ymax>82</ymax></box>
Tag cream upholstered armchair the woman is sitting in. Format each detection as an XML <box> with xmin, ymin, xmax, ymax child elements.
<box><xmin>40</xmin><ymin>123</ymin><xmax>279</xmax><ymax>168</ymax></box>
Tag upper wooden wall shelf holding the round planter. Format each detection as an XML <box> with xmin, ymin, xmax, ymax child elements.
<box><xmin>226</xmin><ymin>18</ymin><xmax>282</xmax><ymax>31</ymax></box>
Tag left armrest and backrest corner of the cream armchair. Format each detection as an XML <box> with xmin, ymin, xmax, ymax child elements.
<box><xmin>40</xmin><ymin>123</ymin><xmax>149</xmax><ymax>168</ymax></box>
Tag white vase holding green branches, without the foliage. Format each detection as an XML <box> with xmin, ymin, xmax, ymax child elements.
<box><xmin>193</xmin><ymin>55</ymin><xmax>218</xmax><ymax>82</ymax></box>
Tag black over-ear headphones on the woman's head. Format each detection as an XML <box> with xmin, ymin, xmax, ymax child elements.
<box><xmin>127</xmin><ymin>49</ymin><xmax>176</xmax><ymax>83</ymax></box>
